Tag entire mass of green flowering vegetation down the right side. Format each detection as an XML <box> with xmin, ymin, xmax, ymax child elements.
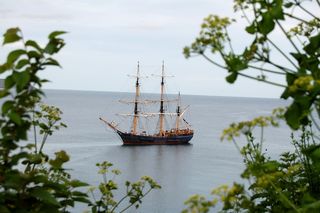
<box><xmin>184</xmin><ymin>0</ymin><xmax>320</xmax><ymax>212</ymax></box>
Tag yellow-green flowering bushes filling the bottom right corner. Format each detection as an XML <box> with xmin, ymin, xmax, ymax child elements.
<box><xmin>183</xmin><ymin>120</ymin><xmax>320</xmax><ymax>213</ymax></box>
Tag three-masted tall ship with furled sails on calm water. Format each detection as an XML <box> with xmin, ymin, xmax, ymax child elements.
<box><xmin>100</xmin><ymin>62</ymin><xmax>194</xmax><ymax>145</ymax></box>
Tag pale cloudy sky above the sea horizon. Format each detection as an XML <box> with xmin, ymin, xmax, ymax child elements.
<box><xmin>0</xmin><ymin>0</ymin><xmax>298</xmax><ymax>98</ymax></box>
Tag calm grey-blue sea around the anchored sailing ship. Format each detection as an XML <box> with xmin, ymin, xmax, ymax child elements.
<box><xmin>39</xmin><ymin>90</ymin><xmax>291</xmax><ymax>213</ymax></box>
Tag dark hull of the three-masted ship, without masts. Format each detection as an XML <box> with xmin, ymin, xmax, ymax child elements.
<box><xmin>117</xmin><ymin>131</ymin><xmax>193</xmax><ymax>145</ymax></box>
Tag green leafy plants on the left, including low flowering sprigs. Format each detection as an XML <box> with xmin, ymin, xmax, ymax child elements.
<box><xmin>0</xmin><ymin>28</ymin><xmax>160</xmax><ymax>213</ymax></box>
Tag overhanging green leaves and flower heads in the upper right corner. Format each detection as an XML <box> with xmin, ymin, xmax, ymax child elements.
<box><xmin>184</xmin><ymin>0</ymin><xmax>320</xmax><ymax>129</ymax></box>
